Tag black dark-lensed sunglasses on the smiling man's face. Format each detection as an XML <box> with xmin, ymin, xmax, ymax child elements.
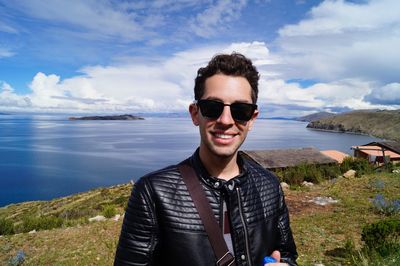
<box><xmin>195</xmin><ymin>100</ymin><xmax>257</xmax><ymax>121</ymax></box>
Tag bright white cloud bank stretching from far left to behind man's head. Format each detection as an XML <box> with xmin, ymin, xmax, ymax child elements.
<box><xmin>0</xmin><ymin>42</ymin><xmax>269</xmax><ymax>112</ymax></box>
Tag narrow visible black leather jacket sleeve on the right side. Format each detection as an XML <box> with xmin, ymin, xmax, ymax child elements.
<box><xmin>278</xmin><ymin>187</ymin><xmax>297</xmax><ymax>266</ymax></box>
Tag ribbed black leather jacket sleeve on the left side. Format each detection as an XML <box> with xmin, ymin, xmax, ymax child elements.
<box><xmin>114</xmin><ymin>178</ymin><xmax>158</xmax><ymax>265</ymax></box>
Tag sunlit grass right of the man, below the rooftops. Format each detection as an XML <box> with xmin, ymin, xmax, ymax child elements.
<box><xmin>292</xmin><ymin>171</ymin><xmax>400</xmax><ymax>265</ymax></box>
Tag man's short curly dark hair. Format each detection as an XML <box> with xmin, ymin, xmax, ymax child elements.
<box><xmin>194</xmin><ymin>53</ymin><xmax>260</xmax><ymax>104</ymax></box>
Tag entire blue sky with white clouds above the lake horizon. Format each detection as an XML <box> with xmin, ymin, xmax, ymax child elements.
<box><xmin>0</xmin><ymin>0</ymin><xmax>400</xmax><ymax>117</ymax></box>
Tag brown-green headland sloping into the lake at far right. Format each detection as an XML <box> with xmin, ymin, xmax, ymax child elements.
<box><xmin>307</xmin><ymin>110</ymin><xmax>400</xmax><ymax>141</ymax></box>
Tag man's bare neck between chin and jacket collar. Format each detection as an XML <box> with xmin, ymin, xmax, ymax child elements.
<box><xmin>199</xmin><ymin>148</ymin><xmax>240</xmax><ymax>180</ymax></box>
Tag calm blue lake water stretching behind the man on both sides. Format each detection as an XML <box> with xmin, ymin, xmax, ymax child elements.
<box><xmin>0</xmin><ymin>115</ymin><xmax>377</xmax><ymax>206</ymax></box>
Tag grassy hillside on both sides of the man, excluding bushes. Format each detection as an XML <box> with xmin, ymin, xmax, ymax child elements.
<box><xmin>0</xmin><ymin>173</ymin><xmax>400</xmax><ymax>265</ymax></box>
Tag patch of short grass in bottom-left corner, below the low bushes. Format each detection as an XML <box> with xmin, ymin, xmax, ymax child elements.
<box><xmin>0</xmin><ymin>220</ymin><xmax>121</xmax><ymax>265</ymax></box>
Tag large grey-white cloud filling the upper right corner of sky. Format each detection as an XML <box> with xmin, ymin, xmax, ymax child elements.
<box><xmin>276</xmin><ymin>0</ymin><xmax>400</xmax><ymax>83</ymax></box>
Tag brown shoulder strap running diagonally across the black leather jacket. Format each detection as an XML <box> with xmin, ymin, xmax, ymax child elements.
<box><xmin>178</xmin><ymin>163</ymin><xmax>235</xmax><ymax>266</ymax></box>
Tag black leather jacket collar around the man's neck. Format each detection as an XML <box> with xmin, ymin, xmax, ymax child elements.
<box><xmin>189</xmin><ymin>148</ymin><xmax>248</xmax><ymax>191</ymax></box>
